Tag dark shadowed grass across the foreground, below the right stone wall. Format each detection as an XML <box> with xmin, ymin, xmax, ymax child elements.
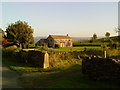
<box><xmin>19</xmin><ymin>64</ymin><xmax>119</xmax><ymax>88</ymax></box>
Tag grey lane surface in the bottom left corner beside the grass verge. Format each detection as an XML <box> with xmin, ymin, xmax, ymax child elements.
<box><xmin>0</xmin><ymin>64</ymin><xmax>22</xmax><ymax>88</ymax></box>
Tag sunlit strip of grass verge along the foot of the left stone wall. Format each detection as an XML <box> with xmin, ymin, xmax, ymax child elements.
<box><xmin>2</xmin><ymin>58</ymin><xmax>52</xmax><ymax>75</ymax></box>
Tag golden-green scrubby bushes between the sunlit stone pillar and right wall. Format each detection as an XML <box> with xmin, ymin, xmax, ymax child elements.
<box><xmin>49</xmin><ymin>52</ymin><xmax>81</xmax><ymax>68</ymax></box>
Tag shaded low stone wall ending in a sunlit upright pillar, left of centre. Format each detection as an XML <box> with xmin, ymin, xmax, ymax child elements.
<box><xmin>19</xmin><ymin>50</ymin><xmax>49</xmax><ymax>68</ymax></box>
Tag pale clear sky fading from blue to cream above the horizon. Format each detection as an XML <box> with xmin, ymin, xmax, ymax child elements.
<box><xmin>0</xmin><ymin>2</ymin><xmax>118</xmax><ymax>37</ymax></box>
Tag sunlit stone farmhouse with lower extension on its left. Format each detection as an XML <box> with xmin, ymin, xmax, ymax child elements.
<box><xmin>36</xmin><ymin>35</ymin><xmax>72</xmax><ymax>48</ymax></box>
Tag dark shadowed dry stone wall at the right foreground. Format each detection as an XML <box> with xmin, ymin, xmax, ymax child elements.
<box><xmin>82</xmin><ymin>57</ymin><xmax>120</xmax><ymax>80</ymax></box>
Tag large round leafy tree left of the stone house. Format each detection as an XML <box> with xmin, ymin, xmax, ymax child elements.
<box><xmin>6</xmin><ymin>21</ymin><xmax>34</xmax><ymax>48</ymax></box>
